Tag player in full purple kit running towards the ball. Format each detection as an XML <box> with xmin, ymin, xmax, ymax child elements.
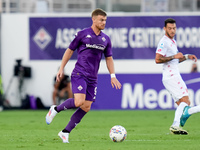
<box><xmin>46</xmin><ymin>9</ymin><xmax>121</xmax><ymax>143</ymax></box>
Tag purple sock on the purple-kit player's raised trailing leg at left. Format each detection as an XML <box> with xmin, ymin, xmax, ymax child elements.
<box><xmin>57</xmin><ymin>98</ymin><xmax>76</xmax><ymax>112</ymax></box>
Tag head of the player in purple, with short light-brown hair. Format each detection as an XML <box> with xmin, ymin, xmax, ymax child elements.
<box><xmin>92</xmin><ymin>8</ymin><xmax>107</xmax><ymax>30</ymax></box>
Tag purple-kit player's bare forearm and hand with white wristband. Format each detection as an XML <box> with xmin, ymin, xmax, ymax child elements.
<box><xmin>105</xmin><ymin>56</ymin><xmax>122</xmax><ymax>89</ymax></box>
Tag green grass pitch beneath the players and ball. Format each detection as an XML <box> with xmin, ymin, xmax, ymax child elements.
<box><xmin>0</xmin><ymin>110</ymin><xmax>200</xmax><ymax>150</ymax></box>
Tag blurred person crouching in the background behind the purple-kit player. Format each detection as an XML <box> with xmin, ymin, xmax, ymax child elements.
<box><xmin>53</xmin><ymin>75</ymin><xmax>73</xmax><ymax>105</ymax></box>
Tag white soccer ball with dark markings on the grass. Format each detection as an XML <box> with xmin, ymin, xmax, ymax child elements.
<box><xmin>109</xmin><ymin>125</ymin><xmax>127</xmax><ymax>142</ymax></box>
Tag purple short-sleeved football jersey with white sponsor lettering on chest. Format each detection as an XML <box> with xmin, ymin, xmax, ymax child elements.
<box><xmin>69</xmin><ymin>27</ymin><xmax>112</xmax><ymax>79</ymax></box>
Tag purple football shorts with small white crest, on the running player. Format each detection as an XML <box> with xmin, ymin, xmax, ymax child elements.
<box><xmin>71</xmin><ymin>74</ymin><xmax>97</xmax><ymax>102</ymax></box>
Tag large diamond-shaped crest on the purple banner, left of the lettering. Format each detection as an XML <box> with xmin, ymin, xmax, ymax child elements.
<box><xmin>33</xmin><ymin>27</ymin><xmax>52</xmax><ymax>50</ymax></box>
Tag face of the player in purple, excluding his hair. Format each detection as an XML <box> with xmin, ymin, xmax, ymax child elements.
<box><xmin>93</xmin><ymin>15</ymin><xmax>107</xmax><ymax>30</ymax></box>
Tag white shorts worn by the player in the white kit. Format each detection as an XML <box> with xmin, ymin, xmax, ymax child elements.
<box><xmin>163</xmin><ymin>76</ymin><xmax>189</xmax><ymax>102</ymax></box>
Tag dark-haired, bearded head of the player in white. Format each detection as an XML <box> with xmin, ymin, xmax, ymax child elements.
<box><xmin>164</xmin><ymin>18</ymin><xmax>176</xmax><ymax>39</ymax></box>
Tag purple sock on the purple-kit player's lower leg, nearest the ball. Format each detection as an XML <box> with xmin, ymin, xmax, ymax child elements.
<box><xmin>65</xmin><ymin>108</ymin><xmax>87</xmax><ymax>132</ymax></box>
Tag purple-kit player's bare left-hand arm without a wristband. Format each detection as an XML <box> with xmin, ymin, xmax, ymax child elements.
<box><xmin>56</xmin><ymin>48</ymin><xmax>74</xmax><ymax>82</ymax></box>
